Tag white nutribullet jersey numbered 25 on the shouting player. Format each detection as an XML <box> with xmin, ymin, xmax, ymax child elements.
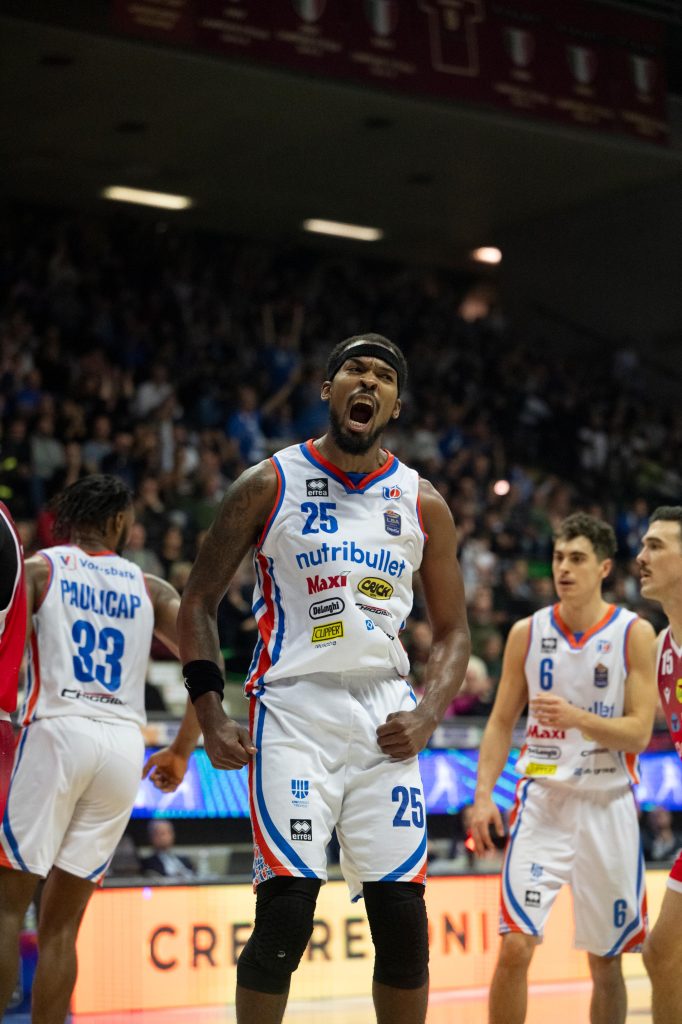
<box><xmin>246</xmin><ymin>441</ymin><xmax>425</xmax><ymax>693</ymax></box>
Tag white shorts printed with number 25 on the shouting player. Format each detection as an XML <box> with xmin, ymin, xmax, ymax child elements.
<box><xmin>249</xmin><ymin>672</ymin><xmax>426</xmax><ymax>899</ymax></box>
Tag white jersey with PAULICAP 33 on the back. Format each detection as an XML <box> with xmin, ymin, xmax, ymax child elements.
<box><xmin>22</xmin><ymin>545</ymin><xmax>154</xmax><ymax>725</ymax></box>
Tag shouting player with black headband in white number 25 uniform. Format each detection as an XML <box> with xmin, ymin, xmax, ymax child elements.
<box><xmin>153</xmin><ymin>334</ymin><xmax>469</xmax><ymax>1024</ymax></box>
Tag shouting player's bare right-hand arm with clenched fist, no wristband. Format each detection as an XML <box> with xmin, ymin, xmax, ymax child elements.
<box><xmin>377</xmin><ymin>480</ymin><xmax>471</xmax><ymax>760</ymax></box>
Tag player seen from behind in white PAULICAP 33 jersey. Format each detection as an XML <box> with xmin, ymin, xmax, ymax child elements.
<box><xmin>0</xmin><ymin>475</ymin><xmax>186</xmax><ymax>1024</ymax></box>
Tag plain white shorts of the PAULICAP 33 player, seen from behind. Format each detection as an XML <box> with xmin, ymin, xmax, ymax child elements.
<box><xmin>0</xmin><ymin>715</ymin><xmax>144</xmax><ymax>882</ymax></box>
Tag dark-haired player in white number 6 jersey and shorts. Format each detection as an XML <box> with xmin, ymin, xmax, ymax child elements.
<box><xmin>472</xmin><ymin>512</ymin><xmax>656</xmax><ymax>1024</ymax></box>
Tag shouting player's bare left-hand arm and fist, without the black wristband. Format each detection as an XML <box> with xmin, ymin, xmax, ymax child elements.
<box><xmin>177</xmin><ymin>461</ymin><xmax>278</xmax><ymax>769</ymax></box>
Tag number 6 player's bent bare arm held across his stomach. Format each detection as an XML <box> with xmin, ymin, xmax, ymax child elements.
<box><xmin>530</xmin><ymin>618</ymin><xmax>658</xmax><ymax>754</ymax></box>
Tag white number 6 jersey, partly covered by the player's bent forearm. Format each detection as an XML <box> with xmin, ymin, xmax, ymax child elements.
<box><xmin>516</xmin><ymin>604</ymin><xmax>639</xmax><ymax>791</ymax></box>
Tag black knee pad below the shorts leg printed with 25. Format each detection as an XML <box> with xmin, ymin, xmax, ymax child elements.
<box><xmin>363</xmin><ymin>882</ymin><xmax>429</xmax><ymax>988</ymax></box>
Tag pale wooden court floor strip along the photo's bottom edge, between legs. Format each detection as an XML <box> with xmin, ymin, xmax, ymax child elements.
<box><xmin>35</xmin><ymin>978</ymin><xmax>651</xmax><ymax>1024</ymax></box>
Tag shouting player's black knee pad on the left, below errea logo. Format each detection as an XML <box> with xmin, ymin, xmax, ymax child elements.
<box><xmin>237</xmin><ymin>877</ymin><xmax>322</xmax><ymax>995</ymax></box>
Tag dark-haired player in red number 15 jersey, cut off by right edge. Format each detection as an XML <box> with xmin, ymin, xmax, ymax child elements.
<box><xmin>637</xmin><ymin>505</ymin><xmax>682</xmax><ymax>1024</ymax></box>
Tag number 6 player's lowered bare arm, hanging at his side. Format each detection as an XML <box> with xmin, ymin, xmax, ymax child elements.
<box><xmin>471</xmin><ymin>618</ymin><xmax>530</xmax><ymax>854</ymax></box>
